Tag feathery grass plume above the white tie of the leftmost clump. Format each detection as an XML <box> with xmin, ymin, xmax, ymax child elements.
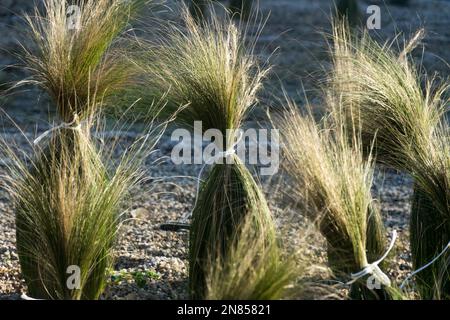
<box><xmin>19</xmin><ymin>0</ymin><xmax>148</xmax><ymax>123</ymax></box>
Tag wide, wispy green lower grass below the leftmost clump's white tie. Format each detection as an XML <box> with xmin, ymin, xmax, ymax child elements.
<box><xmin>0</xmin><ymin>122</ymin><xmax>155</xmax><ymax>299</ymax></box>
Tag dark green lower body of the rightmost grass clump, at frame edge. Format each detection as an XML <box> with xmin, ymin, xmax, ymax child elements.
<box><xmin>410</xmin><ymin>121</ymin><xmax>450</xmax><ymax>299</ymax></box>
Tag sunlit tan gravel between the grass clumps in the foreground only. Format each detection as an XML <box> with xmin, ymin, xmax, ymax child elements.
<box><xmin>0</xmin><ymin>135</ymin><xmax>412</xmax><ymax>299</ymax></box>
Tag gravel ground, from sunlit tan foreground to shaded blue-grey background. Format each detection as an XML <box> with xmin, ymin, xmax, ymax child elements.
<box><xmin>0</xmin><ymin>0</ymin><xmax>450</xmax><ymax>299</ymax></box>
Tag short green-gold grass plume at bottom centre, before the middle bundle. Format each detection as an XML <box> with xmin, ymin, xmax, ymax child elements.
<box><xmin>205</xmin><ymin>200</ymin><xmax>299</xmax><ymax>300</ymax></box>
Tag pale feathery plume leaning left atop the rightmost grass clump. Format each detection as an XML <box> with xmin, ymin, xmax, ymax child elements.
<box><xmin>331</xmin><ymin>23</ymin><xmax>448</xmax><ymax>170</ymax></box>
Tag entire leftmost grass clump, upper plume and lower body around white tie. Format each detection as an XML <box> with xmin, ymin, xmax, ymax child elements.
<box><xmin>2</xmin><ymin>0</ymin><xmax>147</xmax><ymax>299</ymax></box>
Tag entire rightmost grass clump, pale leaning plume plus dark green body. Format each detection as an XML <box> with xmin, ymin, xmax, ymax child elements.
<box><xmin>331</xmin><ymin>24</ymin><xmax>450</xmax><ymax>298</ymax></box>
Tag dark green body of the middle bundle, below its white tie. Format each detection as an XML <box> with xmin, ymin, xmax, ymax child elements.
<box><xmin>189</xmin><ymin>163</ymin><xmax>275</xmax><ymax>299</ymax></box>
